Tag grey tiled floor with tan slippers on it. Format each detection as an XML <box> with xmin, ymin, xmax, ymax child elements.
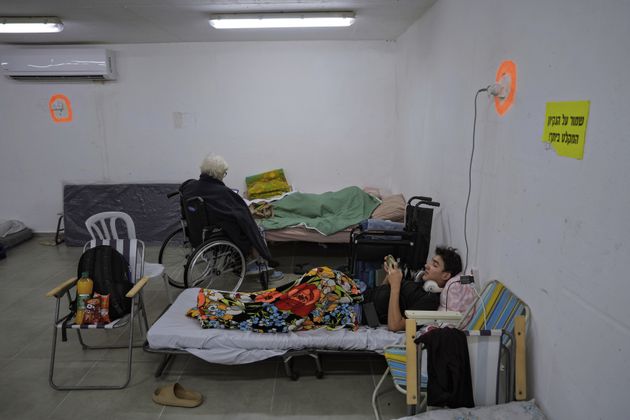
<box><xmin>0</xmin><ymin>237</ymin><xmax>405</xmax><ymax>420</ymax></box>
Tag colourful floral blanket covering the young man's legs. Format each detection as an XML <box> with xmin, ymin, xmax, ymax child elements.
<box><xmin>186</xmin><ymin>267</ymin><xmax>363</xmax><ymax>333</ymax></box>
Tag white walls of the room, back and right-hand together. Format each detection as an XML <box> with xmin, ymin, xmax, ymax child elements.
<box><xmin>0</xmin><ymin>4</ymin><xmax>630</xmax><ymax>419</ymax></box>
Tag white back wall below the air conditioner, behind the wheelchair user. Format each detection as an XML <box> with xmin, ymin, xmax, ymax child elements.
<box><xmin>0</xmin><ymin>42</ymin><xmax>396</xmax><ymax>231</ymax></box>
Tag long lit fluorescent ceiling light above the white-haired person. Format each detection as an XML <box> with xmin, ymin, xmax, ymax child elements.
<box><xmin>209</xmin><ymin>12</ymin><xmax>354</xmax><ymax>29</ymax></box>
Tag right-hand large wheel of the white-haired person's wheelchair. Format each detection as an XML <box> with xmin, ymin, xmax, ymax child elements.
<box><xmin>184</xmin><ymin>239</ymin><xmax>246</xmax><ymax>291</ymax></box>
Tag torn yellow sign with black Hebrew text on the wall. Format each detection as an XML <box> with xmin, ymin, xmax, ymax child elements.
<box><xmin>542</xmin><ymin>101</ymin><xmax>591</xmax><ymax>159</ymax></box>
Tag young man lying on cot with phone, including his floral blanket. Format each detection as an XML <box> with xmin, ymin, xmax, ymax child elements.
<box><xmin>187</xmin><ymin>248</ymin><xmax>472</xmax><ymax>333</ymax></box>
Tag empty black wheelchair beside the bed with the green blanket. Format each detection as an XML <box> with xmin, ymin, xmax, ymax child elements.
<box><xmin>348</xmin><ymin>196</ymin><xmax>440</xmax><ymax>280</ymax></box>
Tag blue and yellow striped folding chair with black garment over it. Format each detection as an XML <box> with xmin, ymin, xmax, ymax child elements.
<box><xmin>372</xmin><ymin>280</ymin><xmax>529</xmax><ymax>419</ymax></box>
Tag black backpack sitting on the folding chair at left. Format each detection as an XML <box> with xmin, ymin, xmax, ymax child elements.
<box><xmin>77</xmin><ymin>245</ymin><xmax>133</xmax><ymax>321</ymax></box>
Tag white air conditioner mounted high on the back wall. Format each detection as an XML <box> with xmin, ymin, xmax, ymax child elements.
<box><xmin>0</xmin><ymin>48</ymin><xmax>116</xmax><ymax>80</ymax></box>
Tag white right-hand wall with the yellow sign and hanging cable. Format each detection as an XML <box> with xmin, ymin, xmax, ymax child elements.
<box><xmin>394</xmin><ymin>0</ymin><xmax>630</xmax><ymax>420</ymax></box>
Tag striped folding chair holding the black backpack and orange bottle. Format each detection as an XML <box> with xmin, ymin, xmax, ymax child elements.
<box><xmin>46</xmin><ymin>239</ymin><xmax>149</xmax><ymax>390</ymax></box>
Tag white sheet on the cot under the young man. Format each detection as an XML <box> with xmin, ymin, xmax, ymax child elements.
<box><xmin>147</xmin><ymin>288</ymin><xmax>405</xmax><ymax>365</ymax></box>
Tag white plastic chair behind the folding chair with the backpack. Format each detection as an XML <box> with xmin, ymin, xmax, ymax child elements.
<box><xmin>85</xmin><ymin>211</ymin><xmax>173</xmax><ymax>303</ymax></box>
